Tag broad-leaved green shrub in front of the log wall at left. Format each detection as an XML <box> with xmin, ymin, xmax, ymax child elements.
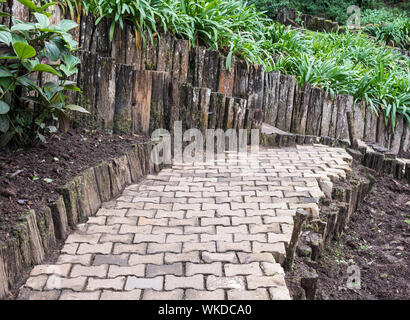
<box><xmin>0</xmin><ymin>0</ymin><xmax>87</xmax><ymax>147</ymax></box>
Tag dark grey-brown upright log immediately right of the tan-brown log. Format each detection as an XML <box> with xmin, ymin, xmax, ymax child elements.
<box><xmin>149</xmin><ymin>71</ymin><xmax>169</xmax><ymax>133</ymax></box>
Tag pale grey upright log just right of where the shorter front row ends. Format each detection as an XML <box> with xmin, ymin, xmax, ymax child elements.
<box><xmin>264</xmin><ymin>71</ymin><xmax>280</xmax><ymax>126</ymax></box>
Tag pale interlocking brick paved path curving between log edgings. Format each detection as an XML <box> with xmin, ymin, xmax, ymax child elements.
<box><xmin>19</xmin><ymin>145</ymin><xmax>351</xmax><ymax>300</ymax></box>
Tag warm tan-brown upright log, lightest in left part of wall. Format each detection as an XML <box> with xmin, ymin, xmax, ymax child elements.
<box><xmin>132</xmin><ymin>70</ymin><xmax>152</xmax><ymax>135</ymax></box>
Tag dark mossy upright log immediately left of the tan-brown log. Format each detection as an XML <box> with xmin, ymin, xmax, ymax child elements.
<box><xmin>114</xmin><ymin>64</ymin><xmax>135</xmax><ymax>134</ymax></box>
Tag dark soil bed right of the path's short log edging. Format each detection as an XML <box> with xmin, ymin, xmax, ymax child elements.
<box><xmin>286</xmin><ymin>172</ymin><xmax>410</xmax><ymax>300</ymax></box>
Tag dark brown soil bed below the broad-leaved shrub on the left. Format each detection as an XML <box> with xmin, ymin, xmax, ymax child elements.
<box><xmin>0</xmin><ymin>129</ymin><xmax>147</xmax><ymax>244</ymax></box>
